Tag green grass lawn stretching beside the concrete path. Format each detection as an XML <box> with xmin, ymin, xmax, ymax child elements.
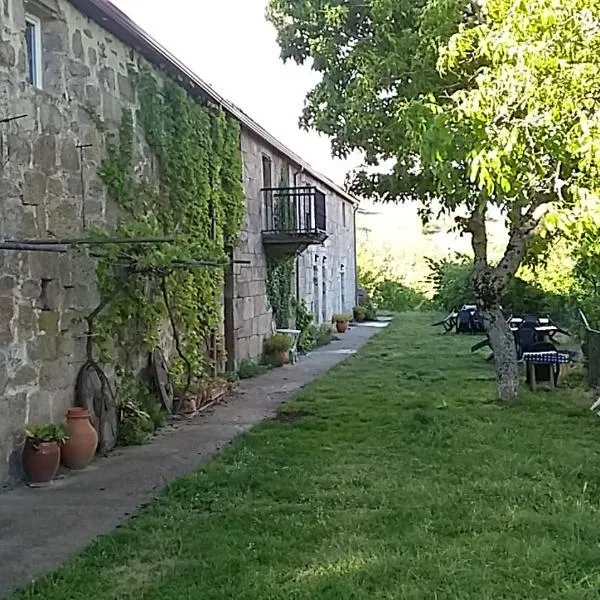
<box><xmin>12</xmin><ymin>315</ymin><xmax>600</xmax><ymax>600</ymax></box>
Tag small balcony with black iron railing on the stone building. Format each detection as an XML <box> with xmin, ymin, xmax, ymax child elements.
<box><xmin>262</xmin><ymin>186</ymin><xmax>327</xmax><ymax>255</ymax></box>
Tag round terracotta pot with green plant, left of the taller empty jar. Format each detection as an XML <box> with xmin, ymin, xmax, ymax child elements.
<box><xmin>23</xmin><ymin>423</ymin><xmax>68</xmax><ymax>483</ymax></box>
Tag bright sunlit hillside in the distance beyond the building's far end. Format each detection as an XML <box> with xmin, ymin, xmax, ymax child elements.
<box><xmin>357</xmin><ymin>201</ymin><xmax>507</xmax><ymax>287</ymax></box>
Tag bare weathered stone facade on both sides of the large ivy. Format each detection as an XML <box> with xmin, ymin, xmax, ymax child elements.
<box><xmin>0</xmin><ymin>0</ymin><xmax>355</xmax><ymax>483</ymax></box>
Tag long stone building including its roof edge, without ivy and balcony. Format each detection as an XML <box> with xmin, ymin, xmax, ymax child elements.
<box><xmin>0</xmin><ymin>0</ymin><xmax>357</xmax><ymax>482</ymax></box>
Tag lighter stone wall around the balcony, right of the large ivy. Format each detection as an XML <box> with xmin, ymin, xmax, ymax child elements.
<box><xmin>234</xmin><ymin>133</ymin><xmax>356</xmax><ymax>362</ymax></box>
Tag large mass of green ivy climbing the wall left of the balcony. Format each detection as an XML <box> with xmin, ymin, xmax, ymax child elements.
<box><xmin>95</xmin><ymin>66</ymin><xmax>244</xmax><ymax>387</ymax></box>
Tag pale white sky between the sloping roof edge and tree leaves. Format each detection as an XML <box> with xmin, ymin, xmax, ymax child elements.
<box><xmin>112</xmin><ymin>0</ymin><xmax>359</xmax><ymax>184</ymax></box>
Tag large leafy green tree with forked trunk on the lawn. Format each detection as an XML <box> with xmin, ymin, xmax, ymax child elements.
<box><xmin>268</xmin><ymin>0</ymin><xmax>600</xmax><ymax>400</ymax></box>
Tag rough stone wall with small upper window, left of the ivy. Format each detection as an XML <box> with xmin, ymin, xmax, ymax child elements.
<box><xmin>0</xmin><ymin>0</ymin><xmax>202</xmax><ymax>483</ymax></box>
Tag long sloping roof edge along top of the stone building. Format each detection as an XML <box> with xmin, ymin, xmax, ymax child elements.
<box><xmin>69</xmin><ymin>0</ymin><xmax>359</xmax><ymax>204</ymax></box>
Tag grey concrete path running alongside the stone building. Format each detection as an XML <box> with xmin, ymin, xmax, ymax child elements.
<box><xmin>0</xmin><ymin>323</ymin><xmax>386</xmax><ymax>598</ymax></box>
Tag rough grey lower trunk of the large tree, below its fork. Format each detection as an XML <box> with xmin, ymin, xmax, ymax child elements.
<box><xmin>482</xmin><ymin>305</ymin><xmax>519</xmax><ymax>402</ymax></box>
